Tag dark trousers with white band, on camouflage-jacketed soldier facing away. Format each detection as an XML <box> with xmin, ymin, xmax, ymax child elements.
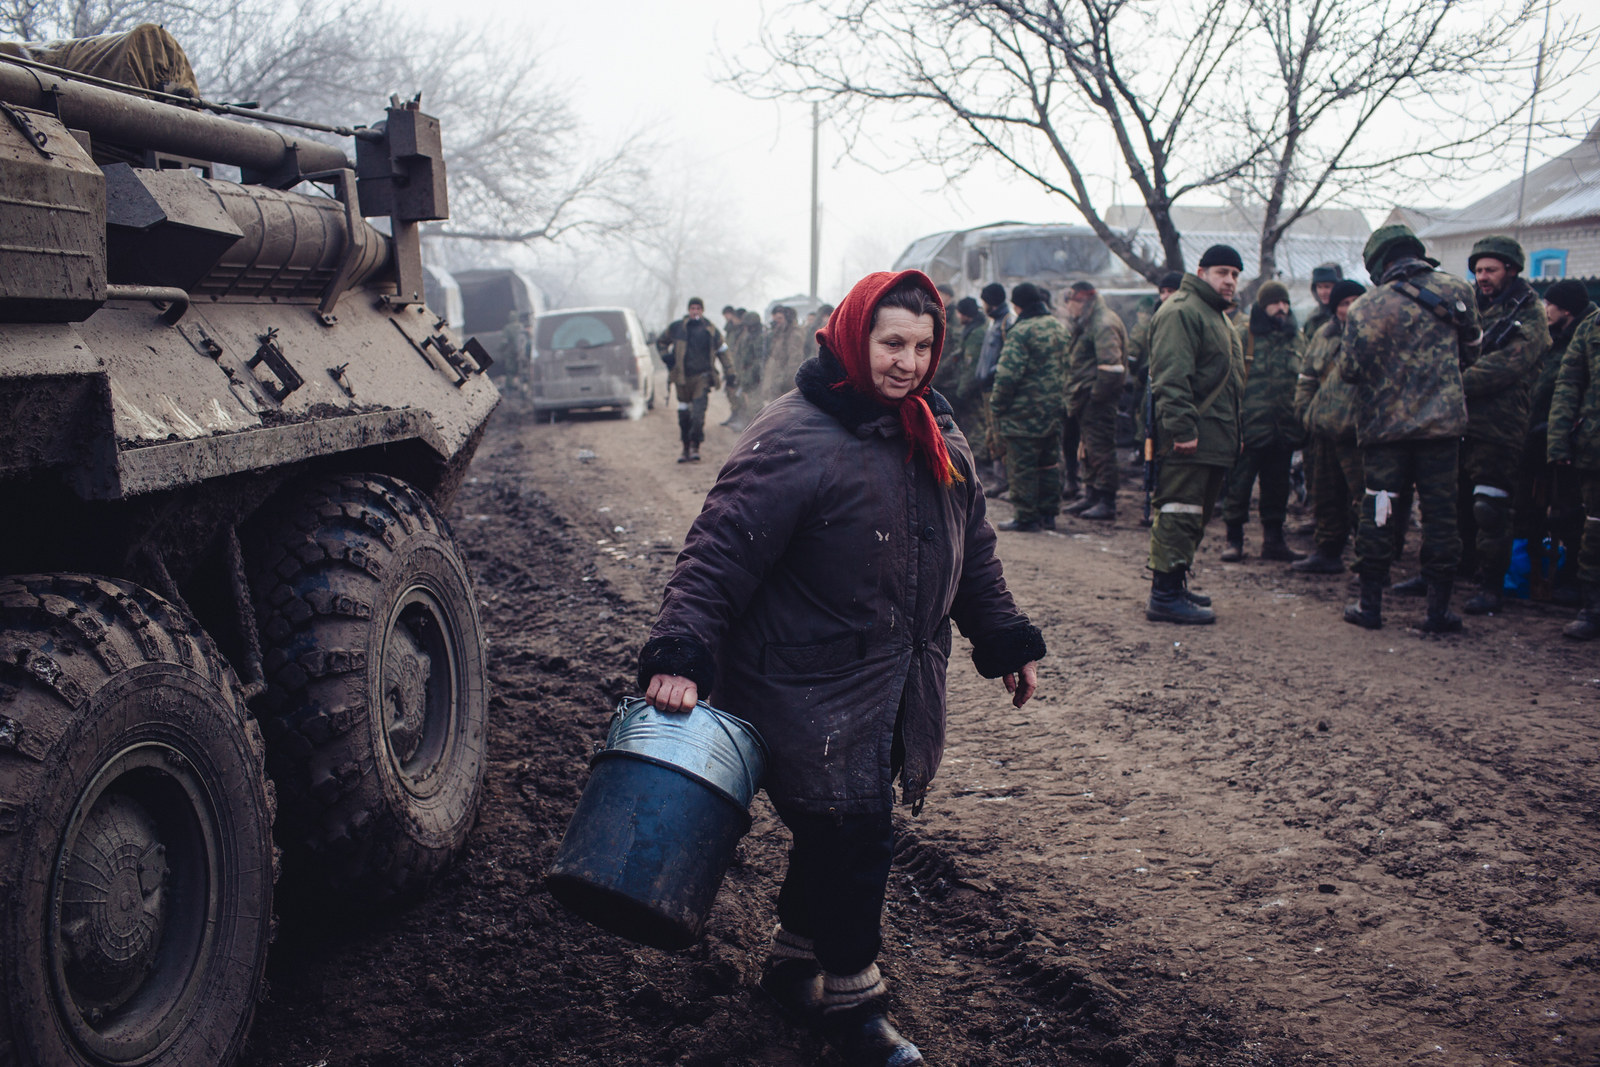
<box><xmin>1355</xmin><ymin>437</ymin><xmax>1461</xmax><ymax>582</ymax></box>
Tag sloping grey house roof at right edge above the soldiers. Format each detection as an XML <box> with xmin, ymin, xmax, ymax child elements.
<box><xmin>1413</xmin><ymin>122</ymin><xmax>1600</xmax><ymax>240</ymax></box>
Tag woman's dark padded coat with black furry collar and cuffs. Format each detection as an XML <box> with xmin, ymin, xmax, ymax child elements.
<box><xmin>638</xmin><ymin>349</ymin><xmax>1045</xmax><ymax>813</ymax></box>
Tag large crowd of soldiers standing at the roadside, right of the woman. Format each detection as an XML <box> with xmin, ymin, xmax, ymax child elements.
<box><xmin>941</xmin><ymin>226</ymin><xmax>1600</xmax><ymax>640</ymax></box>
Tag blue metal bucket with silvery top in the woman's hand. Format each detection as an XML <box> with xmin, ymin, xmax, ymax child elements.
<box><xmin>546</xmin><ymin>697</ymin><xmax>766</xmax><ymax>950</ymax></box>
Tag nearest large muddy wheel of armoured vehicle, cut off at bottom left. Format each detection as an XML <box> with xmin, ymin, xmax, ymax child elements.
<box><xmin>0</xmin><ymin>574</ymin><xmax>275</xmax><ymax>1067</ymax></box>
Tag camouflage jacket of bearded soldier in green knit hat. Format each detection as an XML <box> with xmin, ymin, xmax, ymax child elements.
<box><xmin>1461</xmin><ymin>277</ymin><xmax>1550</xmax><ymax>448</ymax></box>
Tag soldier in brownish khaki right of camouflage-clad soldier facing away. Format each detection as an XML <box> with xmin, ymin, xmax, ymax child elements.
<box><xmin>1066</xmin><ymin>282</ymin><xmax>1128</xmax><ymax>522</ymax></box>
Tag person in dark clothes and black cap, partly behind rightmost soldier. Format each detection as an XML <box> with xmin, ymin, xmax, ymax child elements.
<box><xmin>1512</xmin><ymin>278</ymin><xmax>1597</xmax><ymax>608</ymax></box>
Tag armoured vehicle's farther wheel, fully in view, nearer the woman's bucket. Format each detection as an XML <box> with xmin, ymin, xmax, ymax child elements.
<box><xmin>250</xmin><ymin>475</ymin><xmax>488</xmax><ymax>902</ymax></box>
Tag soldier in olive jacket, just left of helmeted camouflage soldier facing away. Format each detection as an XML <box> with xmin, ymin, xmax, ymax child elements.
<box><xmin>1291</xmin><ymin>278</ymin><xmax>1366</xmax><ymax>574</ymax></box>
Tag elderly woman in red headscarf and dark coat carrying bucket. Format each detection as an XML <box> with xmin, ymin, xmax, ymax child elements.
<box><xmin>638</xmin><ymin>270</ymin><xmax>1045</xmax><ymax>1067</ymax></box>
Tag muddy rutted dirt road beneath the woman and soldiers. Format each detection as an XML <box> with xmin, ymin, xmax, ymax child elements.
<box><xmin>236</xmin><ymin>379</ymin><xmax>1600</xmax><ymax>1067</ymax></box>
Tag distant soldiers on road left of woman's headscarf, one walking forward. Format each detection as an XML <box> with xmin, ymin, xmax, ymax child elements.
<box><xmin>656</xmin><ymin>296</ymin><xmax>834</xmax><ymax>462</ymax></box>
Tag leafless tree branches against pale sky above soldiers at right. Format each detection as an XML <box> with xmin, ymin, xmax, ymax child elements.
<box><xmin>733</xmin><ymin>0</ymin><xmax>1581</xmax><ymax>280</ymax></box>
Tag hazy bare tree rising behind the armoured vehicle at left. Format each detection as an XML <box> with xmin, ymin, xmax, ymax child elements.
<box><xmin>0</xmin><ymin>0</ymin><xmax>646</xmax><ymax>242</ymax></box>
